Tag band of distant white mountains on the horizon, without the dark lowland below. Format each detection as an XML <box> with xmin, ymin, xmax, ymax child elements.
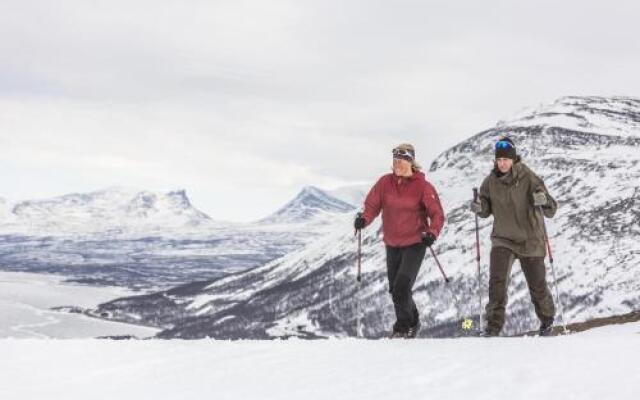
<box><xmin>0</xmin><ymin>186</ymin><xmax>364</xmax><ymax>237</ymax></box>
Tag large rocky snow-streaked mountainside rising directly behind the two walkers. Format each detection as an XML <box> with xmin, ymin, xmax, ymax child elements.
<box><xmin>92</xmin><ymin>97</ymin><xmax>640</xmax><ymax>338</ymax></box>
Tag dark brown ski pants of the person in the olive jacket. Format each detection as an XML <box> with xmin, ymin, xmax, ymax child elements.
<box><xmin>486</xmin><ymin>247</ymin><xmax>556</xmax><ymax>334</ymax></box>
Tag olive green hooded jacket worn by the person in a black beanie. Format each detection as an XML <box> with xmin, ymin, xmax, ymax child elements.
<box><xmin>478</xmin><ymin>159</ymin><xmax>558</xmax><ymax>257</ymax></box>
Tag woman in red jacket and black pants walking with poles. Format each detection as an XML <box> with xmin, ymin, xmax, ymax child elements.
<box><xmin>354</xmin><ymin>144</ymin><xmax>444</xmax><ymax>338</ymax></box>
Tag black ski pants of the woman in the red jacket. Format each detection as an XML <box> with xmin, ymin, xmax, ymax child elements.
<box><xmin>387</xmin><ymin>243</ymin><xmax>427</xmax><ymax>332</ymax></box>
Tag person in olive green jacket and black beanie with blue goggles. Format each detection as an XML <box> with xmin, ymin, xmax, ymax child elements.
<box><xmin>471</xmin><ymin>137</ymin><xmax>558</xmax><ymax>336</ymax></box>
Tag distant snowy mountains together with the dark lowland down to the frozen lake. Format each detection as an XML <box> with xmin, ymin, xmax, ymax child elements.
<box><xmin>0</xmin><ymin>183</ymin><xmax>355</xmax><ymax>290</ymax></box>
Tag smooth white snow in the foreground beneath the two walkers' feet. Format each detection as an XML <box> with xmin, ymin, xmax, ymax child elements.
<box><xmin>0</xmin><ymin>323</ymin><xmax>640</xmax><ymax>400</ymax></box>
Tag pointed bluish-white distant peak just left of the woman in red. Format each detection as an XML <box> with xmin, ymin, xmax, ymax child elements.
<box><xmin>260</xmin><ymin>186</ymin><xmax>355</xmax><ymax>224</ymax></box>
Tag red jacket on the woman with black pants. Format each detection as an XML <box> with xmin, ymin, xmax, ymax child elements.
<box><xmin>363</xmin><ymin>172</ymin><xmax>444</xmax><ymax>247</ymax></box>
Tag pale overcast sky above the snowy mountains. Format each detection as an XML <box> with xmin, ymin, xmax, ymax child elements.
<box><xmin>0</xmin><ymin>0</ymin><xmax>640</xmax><ymax>221</ymax></box>
